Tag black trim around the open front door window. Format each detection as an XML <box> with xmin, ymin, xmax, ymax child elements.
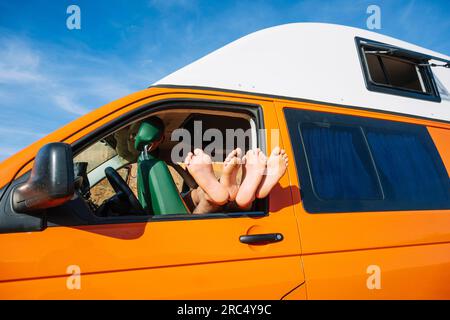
<box><xmin>47</xmin><ymin>98</ymin><xmax>269</xmax><ymax>227</ymax></box>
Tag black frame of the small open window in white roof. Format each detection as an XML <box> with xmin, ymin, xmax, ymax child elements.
<box><xmin>355</xmin><ymin>37</ymin><xmax>442</xmax><ymax>103</ymax></box>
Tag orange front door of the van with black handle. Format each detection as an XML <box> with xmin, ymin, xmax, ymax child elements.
<box><xmin>0</xmin><ymin>94</ymin><xmax>304</xmax><ymax>299</ymax></box>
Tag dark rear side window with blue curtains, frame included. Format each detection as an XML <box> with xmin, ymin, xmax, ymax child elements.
<box><xmin>285</xmin><ymin>109</ymin><xmax>450</xmax><ymax>213</ymax></box>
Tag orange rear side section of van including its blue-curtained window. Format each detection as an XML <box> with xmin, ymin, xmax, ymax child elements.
<box><xmin>276</xmin><ymin>102</ymin><xmax>450</xmax><ymax>299</ymax></box>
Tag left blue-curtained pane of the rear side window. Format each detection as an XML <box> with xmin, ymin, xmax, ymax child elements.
<box><xmin>301</xmin><ymin>123</ymin><xmax>381</xmax><ymax>200</ymax></box>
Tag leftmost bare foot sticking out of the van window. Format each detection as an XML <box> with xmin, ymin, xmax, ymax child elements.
<box><xmin>184</xmin><ymin>149</ymin><xmax>228</xmax><ymax>205</ymax></box>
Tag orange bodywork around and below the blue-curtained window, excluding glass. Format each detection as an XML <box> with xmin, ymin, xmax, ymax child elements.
<box><xmin>276</xmin><ymin>101</ymin><xmax>450</xmax><ymax>299</ymax></box>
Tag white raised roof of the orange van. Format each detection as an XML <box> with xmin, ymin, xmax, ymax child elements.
<box><xmin>154</xmin><ymin>23</ymin><xmax>450</xmax><ymax>121</ymax></box>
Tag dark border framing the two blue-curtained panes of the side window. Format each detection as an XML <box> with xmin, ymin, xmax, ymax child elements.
<box><xmin>283</xmin><ymin>107</ymin><xmax>450</xmax><ymax>214</ymax></box>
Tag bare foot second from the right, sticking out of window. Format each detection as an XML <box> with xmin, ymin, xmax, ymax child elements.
<box><xmin>236</xmin><ymin>149</ymin><xmax>267</xmax><ymax>208</ymax></box>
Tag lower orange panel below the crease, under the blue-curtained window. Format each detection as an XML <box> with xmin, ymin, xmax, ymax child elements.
<box><xmin>303</xmin><ymin>243</ymin><xmax>450</xmax><ymax>299</ymax></box>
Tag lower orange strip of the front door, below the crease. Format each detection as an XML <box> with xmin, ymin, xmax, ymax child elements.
<box><xmin>0</xmin><ymin>256</ymin><xmax>305</xmax><ymax>300</ymax></box>
